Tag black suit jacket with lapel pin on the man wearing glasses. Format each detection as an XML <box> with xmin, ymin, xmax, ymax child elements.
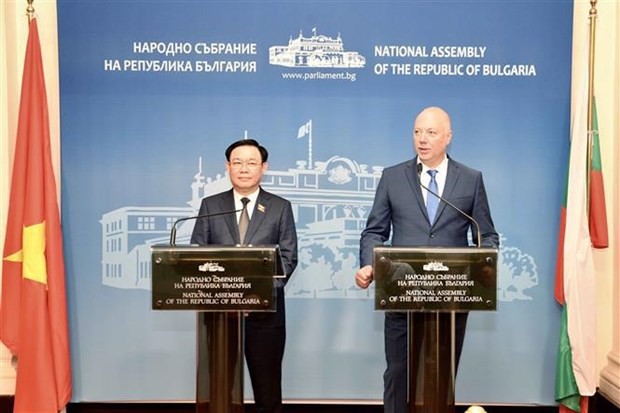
<box><xmin>191</xmin><ymin>188</ymin><xmax>297</xmax><ymax>325</ymax></box>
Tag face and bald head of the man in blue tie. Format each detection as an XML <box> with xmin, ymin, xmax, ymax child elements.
<box><xmin>413</xmin><ymin>109</ymin><xmax>452</xmax><ymax>168</ymax></box>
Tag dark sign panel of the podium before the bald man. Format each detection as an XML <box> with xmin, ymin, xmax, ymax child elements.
<box><xmin>374</xmin><ymin>247</ymin><xmax>497</xmax><ymax>311</ymax></box>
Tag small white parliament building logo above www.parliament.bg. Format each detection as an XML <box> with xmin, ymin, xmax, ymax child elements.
<box><xmin>269</xmin><ymin>27</ymin><xmax>366</xmax><ymax>68</ymax></box>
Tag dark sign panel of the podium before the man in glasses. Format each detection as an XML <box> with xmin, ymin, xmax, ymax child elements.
<box><xmin>151</xmin><ymin>245</ymin><xmax>284</xmax><ymax>311</ymax></box>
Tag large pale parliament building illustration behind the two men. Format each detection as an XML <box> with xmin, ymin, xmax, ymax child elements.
<box><xmin>100</xmin><ymin>127</ymin><xmax>539</xmax><ymax>301</ymax></box>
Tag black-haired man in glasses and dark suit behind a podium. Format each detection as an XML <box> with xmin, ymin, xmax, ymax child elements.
<box><xmin>191</xmin><ymin>139</ymin><xmax>297</xmax><ymax>413</ymax></box>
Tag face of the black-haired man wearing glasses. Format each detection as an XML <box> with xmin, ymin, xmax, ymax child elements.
<box><xmin>226</xmin><ymin>145</ymin><xmax>267</xmax><ymax>195</ymax></box>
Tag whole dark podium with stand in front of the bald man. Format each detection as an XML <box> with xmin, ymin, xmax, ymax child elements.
<box><xmin>373</xmin><ymin>246</ymin><xmax>498</xmax><ymax>413</ymax></box>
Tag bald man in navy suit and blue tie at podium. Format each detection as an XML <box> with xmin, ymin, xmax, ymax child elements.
<box><xmin>355</xmin><ymin>107</ymin><xmax>499</xmax><ymax>413</ymax></box>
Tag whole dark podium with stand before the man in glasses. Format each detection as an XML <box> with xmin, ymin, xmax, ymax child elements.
<box><xmin>151</xmin><ymin>245</ymin><xmax>285</xmax><ymax>413</ymax></box>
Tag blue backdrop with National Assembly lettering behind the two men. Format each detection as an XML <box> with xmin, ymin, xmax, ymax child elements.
<box><xmin>58</xmin><ymin>0</ymin><xmax>573</xmax><ymax>404</ymax></box>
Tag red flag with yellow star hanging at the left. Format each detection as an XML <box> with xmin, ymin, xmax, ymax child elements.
<box><xmin>0</xmin><ymin>18</ymin><xmax>71</xmax><ymax>413</ymax></box>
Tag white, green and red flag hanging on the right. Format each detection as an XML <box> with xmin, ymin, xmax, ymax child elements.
<box><xmin>555</xmin><ymin>26</ymin><xmax>607</xmax><ymax>413</ymax></box>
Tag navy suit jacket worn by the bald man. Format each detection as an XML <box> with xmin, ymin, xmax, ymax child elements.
<box><xmin>360</xmin><ymin>154</ymin><xmax>499</xmax><ymax>267</ymax></box>
